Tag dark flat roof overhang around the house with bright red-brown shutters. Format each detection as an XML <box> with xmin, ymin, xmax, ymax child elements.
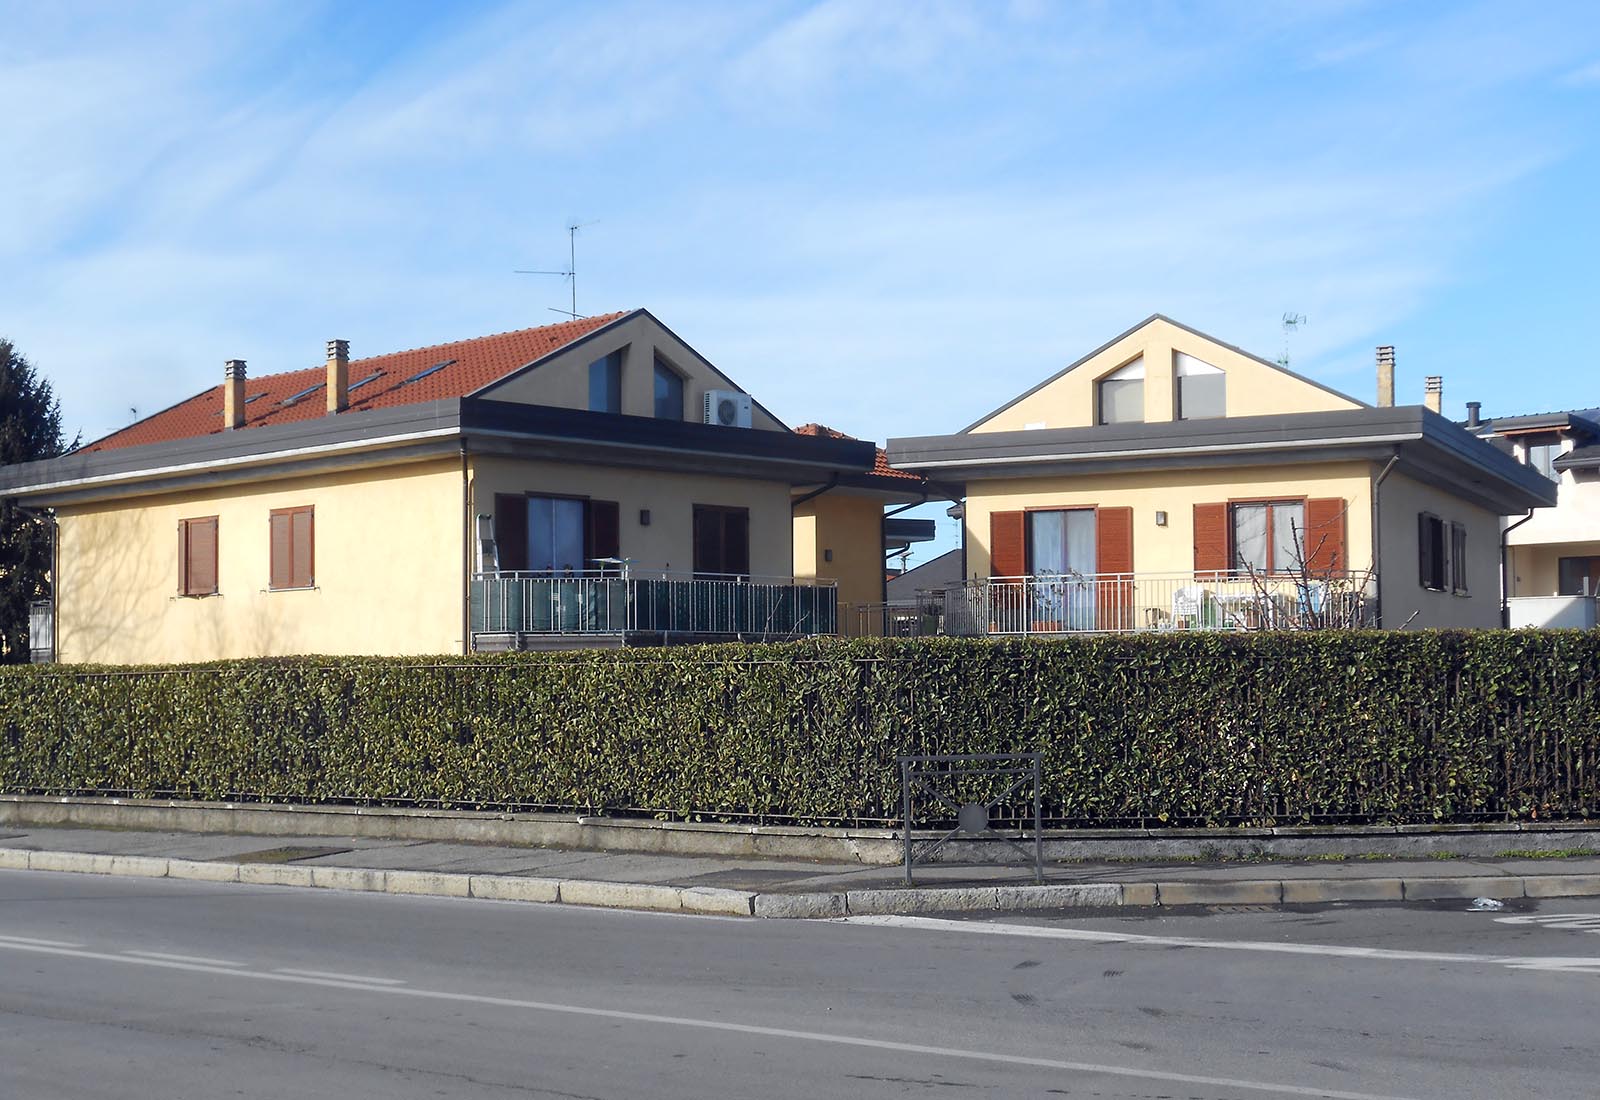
<box><xmin>888</xmin><ymin>405</ymin><xmax>1555</xmax><ymax>515</ymax></box>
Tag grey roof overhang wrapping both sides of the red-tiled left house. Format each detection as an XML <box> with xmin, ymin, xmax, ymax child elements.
<box><xmin>0</xmin><ymin>398</ymin><xmax>875</xmax><ymax>507</ymax></box>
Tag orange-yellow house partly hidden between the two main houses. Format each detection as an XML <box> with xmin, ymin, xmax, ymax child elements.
<box><xmin>794</xmin><ymin>424</ymin><xmax>939</xmax><ymax>635</ymax></box>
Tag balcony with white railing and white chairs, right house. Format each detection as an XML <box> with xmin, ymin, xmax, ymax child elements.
<box><xmin>923</xmin><ymin>572</ymin><xmax>1371</xmax><ymax>636</ymax></box>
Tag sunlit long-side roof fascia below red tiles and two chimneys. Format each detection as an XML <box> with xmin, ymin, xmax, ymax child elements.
<box><xmin>0</xmin><ymin>398</ymin><xmax>461</xmax><ymax>497</ymax></box>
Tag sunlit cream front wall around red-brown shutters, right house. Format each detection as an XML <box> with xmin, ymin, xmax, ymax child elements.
<box><xmin>966</xmin><ymin>462</ymin><xmax>1373</xmax><ymax>577</ymax></box>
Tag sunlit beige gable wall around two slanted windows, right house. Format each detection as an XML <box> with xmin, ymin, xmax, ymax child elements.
<box><xmin>971</xmin><ymin>318</ymin><xmax>1360</xmax><ymax>432</ymax></box>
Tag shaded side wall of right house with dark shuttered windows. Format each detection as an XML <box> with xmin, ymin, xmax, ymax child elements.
<box><xmin>1378</xmin><ymin>473</ymin><xmax>1501</xmax><ymax>628</ymax></box>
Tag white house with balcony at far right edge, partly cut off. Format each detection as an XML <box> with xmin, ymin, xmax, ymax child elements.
<box><xmin>1464</xmin><ymin>401</ymin><xmax>1600</xmax><ymax>627</ymax></box>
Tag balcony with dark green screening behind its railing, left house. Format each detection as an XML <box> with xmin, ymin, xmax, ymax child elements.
<box><xmin>472</xmin><ymin>571</ymin><xmax>838</xmax><ymax>651</ymax></box>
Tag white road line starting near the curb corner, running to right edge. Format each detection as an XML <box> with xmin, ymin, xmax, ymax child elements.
<box><xmin>835</xmin><ymin>916</ymin><xmax>1600</xmax><ymax>974</ymax></box>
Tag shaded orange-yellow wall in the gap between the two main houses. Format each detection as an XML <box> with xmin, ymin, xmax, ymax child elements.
<box><xmin>794</xmin><ymin>489</ymin><xmax>883</xmax><ymax>632</ymax></box>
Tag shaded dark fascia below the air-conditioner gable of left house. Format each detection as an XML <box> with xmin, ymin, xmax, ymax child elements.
<box><xmin>461</xmin><ymin>398</ymin><xmax>877</xmax><ymax>480</ymax></box>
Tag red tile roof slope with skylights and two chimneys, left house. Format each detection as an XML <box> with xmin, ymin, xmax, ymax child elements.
<box><xmin>83</xmin><ymin>313</ymin><xmax>627</xmax><ymax>451</ymax></box>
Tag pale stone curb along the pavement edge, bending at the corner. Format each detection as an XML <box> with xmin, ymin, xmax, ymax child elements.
<box><xmin>9</xmin><ymin>847</ymin><xmax>1600</xmax><ymax>919</ymax></box>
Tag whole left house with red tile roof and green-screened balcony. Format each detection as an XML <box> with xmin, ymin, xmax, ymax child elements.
<box><xmin>0</xmin><ymin>310</ymin><xmax>883</xmax><ymax>664</ymax></box>
